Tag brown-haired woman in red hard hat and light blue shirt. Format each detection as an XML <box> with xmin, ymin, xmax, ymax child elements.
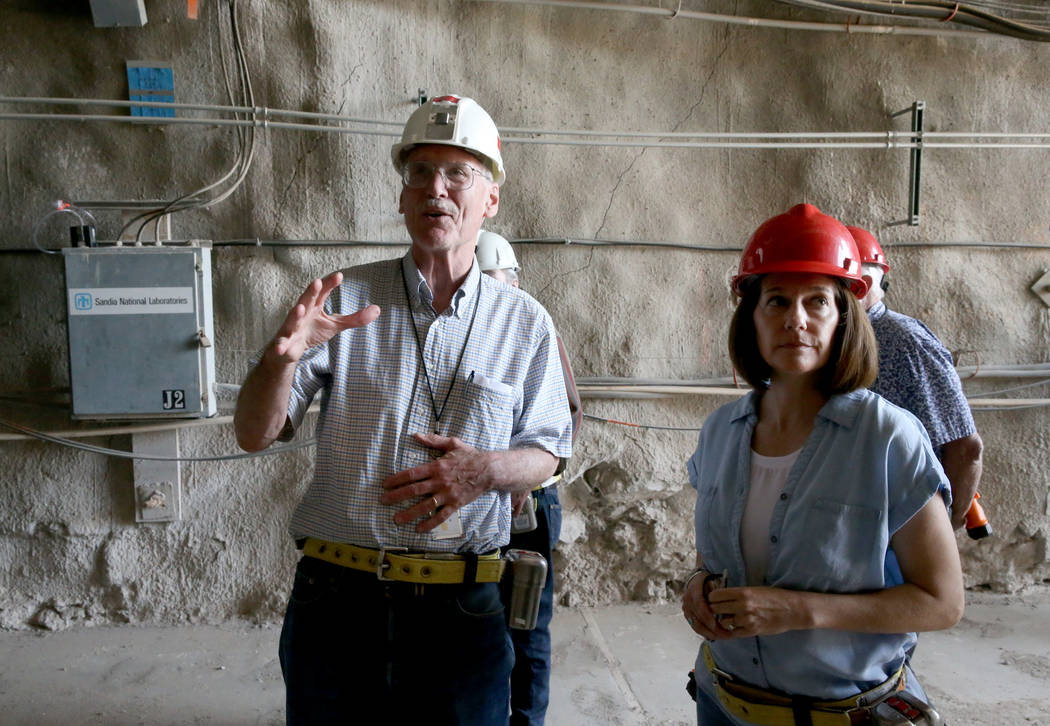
<box><xmin>683</xmin><ymin>204</ymin><xmax>963</xmax><ymax>726</ymax></box>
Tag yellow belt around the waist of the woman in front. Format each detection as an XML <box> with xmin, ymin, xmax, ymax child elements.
<box><xmin>700</xmin><ymin>643</ymin><xmax>905</xmax><ymax>726</ymax></box>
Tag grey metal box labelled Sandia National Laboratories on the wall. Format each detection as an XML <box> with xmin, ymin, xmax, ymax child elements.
<box><xmin>62</xmin><ymin>242</ymin><xmax>216</xmax><ymax>419</ymax></box>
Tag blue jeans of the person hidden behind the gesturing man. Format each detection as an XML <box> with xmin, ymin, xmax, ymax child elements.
<box><xmin>503</xmin><ymin>486</ymin><xmax>562</xmax><ymax>726</ymax></box>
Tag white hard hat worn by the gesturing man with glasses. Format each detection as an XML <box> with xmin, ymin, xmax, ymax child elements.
<box><xmin>391</xmin><ymin>96</ymin><xmax>507</xmax><ymax>184</ymax></box>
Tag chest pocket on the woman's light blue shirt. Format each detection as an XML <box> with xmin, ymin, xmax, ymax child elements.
<box><xmin>778</xmin><ymin>497</ymin><xmax>886</xmax><ymax>593</ymax></box>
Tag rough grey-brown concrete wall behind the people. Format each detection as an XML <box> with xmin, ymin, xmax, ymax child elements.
<box><xmin>0</xmin><ymin>0</ymin><xmax>1050</xmax><ymax>628</ymax></box>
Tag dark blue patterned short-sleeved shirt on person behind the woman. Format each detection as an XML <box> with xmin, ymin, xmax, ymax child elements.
<box><xmin>867</xmin><ymin>302</ymin><xmax>977</xmax><ymax>451</ymax></box>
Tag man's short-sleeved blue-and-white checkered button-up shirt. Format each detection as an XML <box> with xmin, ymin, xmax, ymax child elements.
<box><xmin>288</xmin><ymin>253</ymin><xmax>572</xmax><ymax>553</ymax></box>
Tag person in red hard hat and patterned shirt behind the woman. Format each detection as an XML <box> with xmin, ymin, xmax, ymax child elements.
<box><xmin>846</xmin><ymin>227</ymin><xmax>984</xmax><ymax>530</ymax></box>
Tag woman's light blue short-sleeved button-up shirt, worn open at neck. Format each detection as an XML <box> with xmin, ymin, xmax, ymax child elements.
<box><xmin>687</xmin><ymin>390</ymin><xmax>951</xmax><ymax>700</ymax></box>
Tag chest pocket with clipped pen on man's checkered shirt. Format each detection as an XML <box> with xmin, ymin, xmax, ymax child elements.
<box><xmin>447</xmin><ymin>378</ymin><xmax>517</xmax><ymax>451</ymax></box>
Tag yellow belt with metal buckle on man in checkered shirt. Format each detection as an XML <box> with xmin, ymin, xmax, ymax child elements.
<box><xmin>302</xmin><ymin>537</ymin><xmax>504</xmax><ymax>585</ymax></box>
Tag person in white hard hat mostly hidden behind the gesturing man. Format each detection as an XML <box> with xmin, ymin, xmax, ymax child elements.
<box><xmin>477</xmin><ymin>230</ymin><xmax>584</xmax><ymax>726</ymax></box>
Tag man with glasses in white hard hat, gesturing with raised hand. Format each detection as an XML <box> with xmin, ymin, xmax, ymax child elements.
<box><xmin>234</xmin><ymin>96</ymin><xmax>572</xmax><ymax>726</ymax></box>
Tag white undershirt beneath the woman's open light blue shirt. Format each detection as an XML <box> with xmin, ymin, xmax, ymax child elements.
<box><xmin>740</xmin><ymin>449</ymin><xmax>802</xmax><ymax>587</ymax></box>
